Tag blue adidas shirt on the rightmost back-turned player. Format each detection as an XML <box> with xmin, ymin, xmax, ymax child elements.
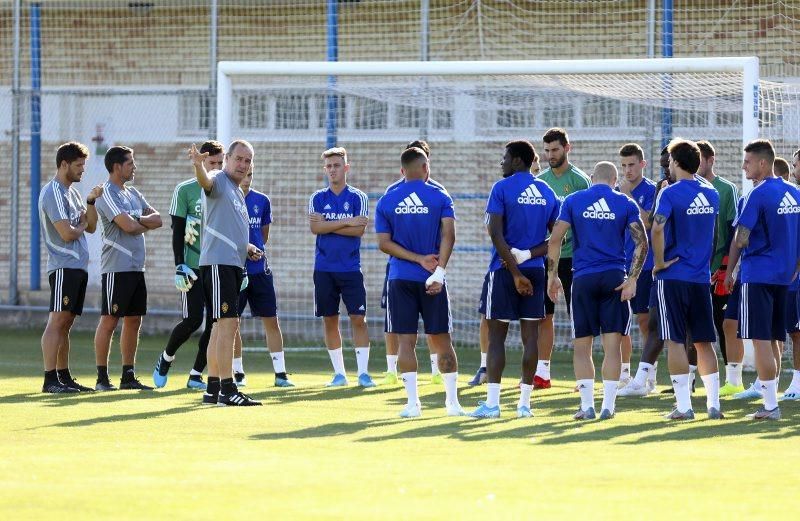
<box><xmin>733</xmin><ymin>177</ymin><xmax>800</xmax><ymax>285</ymax></box>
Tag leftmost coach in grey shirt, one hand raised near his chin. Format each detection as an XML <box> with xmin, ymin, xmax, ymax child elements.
<box><xmin>34</xmin><ymin>142</ymin><xmax>103</xmax><ymax>393</ymax></box>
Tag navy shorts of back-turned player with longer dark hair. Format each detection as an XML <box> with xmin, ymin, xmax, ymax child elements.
<box><xmin>656</xmin><ymin>280</ymin><xmax>717</xmax><ymax>344</ymax></box>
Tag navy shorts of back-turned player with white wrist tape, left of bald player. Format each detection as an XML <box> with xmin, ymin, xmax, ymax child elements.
<box><xmin>478</xmin><ymin>268</ymin><xmax>544</xmax><ymax>321</ymax></box>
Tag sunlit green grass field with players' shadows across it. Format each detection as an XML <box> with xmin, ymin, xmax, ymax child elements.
<box><xmin>0</xmin><ymin>331</ymin><xmax>800</xmax><ymax>520</ymax></box>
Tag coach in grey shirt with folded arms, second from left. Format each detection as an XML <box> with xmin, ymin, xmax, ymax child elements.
<box><xmin>94</xmin><ymin>146</ymin><xmax>161</xmax><ymax>391</ymax></box>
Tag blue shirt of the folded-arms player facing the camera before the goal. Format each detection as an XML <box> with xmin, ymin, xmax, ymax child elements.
<box><xmin>308</xmin><ymin>185</ymin><xmax>369</xmax><ymax>272</ymax></box>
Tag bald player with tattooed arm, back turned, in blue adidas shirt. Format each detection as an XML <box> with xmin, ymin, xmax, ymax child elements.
<box><xmin>547</xmin><ymin>161</ymin><xmax>648</xmax><ymax>420</ymax></box>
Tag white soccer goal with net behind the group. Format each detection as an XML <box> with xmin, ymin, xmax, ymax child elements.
<box><xmin>216</xmin><ymin>58</ymin><xmax>764</xmax><ymax>346</ymax></box>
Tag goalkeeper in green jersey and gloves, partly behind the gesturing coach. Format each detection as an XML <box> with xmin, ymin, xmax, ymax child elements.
<box><xmin>153</xmin><ymin>141</ymin><xmax>225</xmax><ymax>390</ymax></box>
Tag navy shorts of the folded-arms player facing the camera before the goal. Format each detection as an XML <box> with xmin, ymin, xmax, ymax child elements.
<box><xmin>314</xmin><ymin>270</ymin><xmax>367</xmax><ymax>317</ymax></box>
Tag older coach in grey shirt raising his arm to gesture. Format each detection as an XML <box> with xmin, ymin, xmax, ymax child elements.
<box><xmin>189</xmin><ymin>140</ymin><xmax>263</xmax><ymax>406</ymax></box>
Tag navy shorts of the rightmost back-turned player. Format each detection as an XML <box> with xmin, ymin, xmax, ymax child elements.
<box><xmin>739</xmin><ymin>282</ymin><xmax>788</xmax><ymax>342</ymax></box>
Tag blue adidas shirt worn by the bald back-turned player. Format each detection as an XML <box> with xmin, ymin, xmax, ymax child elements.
<box><xmin>558</xmin><ymin>184</ymin><xmax>639</xmax><ymax>277</ymax></box>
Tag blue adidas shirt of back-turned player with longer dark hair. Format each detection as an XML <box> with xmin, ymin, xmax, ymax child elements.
<box><xmin>655</xmin><ymin>177</ymin><xmax>719</xmax><ymax>284</ymax></box>
